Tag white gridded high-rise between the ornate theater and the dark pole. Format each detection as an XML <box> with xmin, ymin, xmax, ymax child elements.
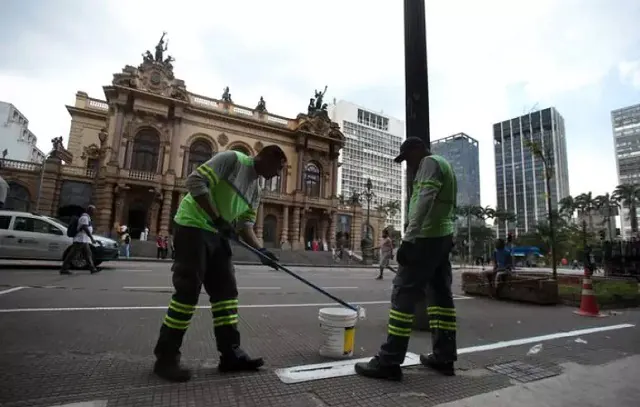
<box><xmin>328</xmin><ymin>100</ymin><xmax>405</xmax><ymax>231</ymax></box>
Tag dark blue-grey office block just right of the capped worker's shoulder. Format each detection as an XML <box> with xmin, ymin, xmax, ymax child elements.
<box><xmin>431</xmin><ymin>133</ymin><xmax>480</xmax><ymax>206</ymax></box>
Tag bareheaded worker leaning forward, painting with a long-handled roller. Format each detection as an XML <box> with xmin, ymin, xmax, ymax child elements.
<box><xmin>154</xmin><ymin>145</ymin><xmax>286</xmax><ymax>382</ymax></box>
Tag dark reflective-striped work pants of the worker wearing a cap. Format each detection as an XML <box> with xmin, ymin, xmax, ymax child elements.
<box><xmin>378</xmin><ymin>236</ymin><xmax>457</xmax><ymax>365</ymax></box>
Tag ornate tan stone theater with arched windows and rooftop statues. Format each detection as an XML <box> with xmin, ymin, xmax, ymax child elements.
<box><xmin>0</xmin><ymin>35</ymin><xmax>384</xmax><ymax>249</ymax></box>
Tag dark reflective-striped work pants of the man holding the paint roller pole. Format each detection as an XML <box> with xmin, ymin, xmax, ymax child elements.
<box><xmin>154</xmin><ymin>226</ymin><xmax>245</xmax><ymax>359</ymax></box>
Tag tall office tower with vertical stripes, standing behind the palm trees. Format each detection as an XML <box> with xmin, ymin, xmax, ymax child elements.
<box><xmin>493</xmin><ymin>107</ymin><xmax>570</xmax><ymax>237</ymax></box>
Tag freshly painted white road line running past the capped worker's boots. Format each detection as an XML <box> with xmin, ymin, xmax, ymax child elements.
<box><xmin>276</xmin><ymin>324</ymin><xmax>635</xmax><ymax>384</ymax></box>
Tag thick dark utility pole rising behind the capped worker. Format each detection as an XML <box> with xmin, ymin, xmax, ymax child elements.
<box><xmin>404</xmin><ymin>0</ymin><xmax>431</xmax><ymax>331</ymax></box>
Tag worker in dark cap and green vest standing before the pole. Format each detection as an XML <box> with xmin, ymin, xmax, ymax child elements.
<box><xmin>355</xmin><ymin>137</ymin><xmax>457</xmax><ymax>380</ymax></box>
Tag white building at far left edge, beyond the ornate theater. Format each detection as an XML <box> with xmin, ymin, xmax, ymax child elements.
<box><xmin>0</xmin><ymin>102</ymin><xmax>44</xmax><ymax>163</ymax></box>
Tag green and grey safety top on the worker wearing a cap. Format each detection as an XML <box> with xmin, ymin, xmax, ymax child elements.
<box><xmin>409</xmin><ymin>155</ymin><xmax>458</xmax><ymax>237</ymax></box>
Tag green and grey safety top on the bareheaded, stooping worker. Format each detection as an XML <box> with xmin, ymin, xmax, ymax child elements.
<box><xmin>174</xmin><ymin>151</ymin><xmax>260</xmax><ymax>232</ymax></box>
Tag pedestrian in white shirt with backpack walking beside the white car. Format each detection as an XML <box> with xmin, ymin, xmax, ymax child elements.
<box><xmin>60</xmin><ymin>205</ymin><xmax>100</xmax><ymax>274</ymax></box>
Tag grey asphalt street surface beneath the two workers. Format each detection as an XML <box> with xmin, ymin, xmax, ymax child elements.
<box><xmin>0</xmin><ymin>261</ymin><xmax>640</xmax><ymax>407</ymax></box>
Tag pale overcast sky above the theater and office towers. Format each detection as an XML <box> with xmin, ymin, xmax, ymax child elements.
<box><xmin>0</xmin><ymin>0</ymin><xmax>640</xmax><ymax>209</ymax></box>
